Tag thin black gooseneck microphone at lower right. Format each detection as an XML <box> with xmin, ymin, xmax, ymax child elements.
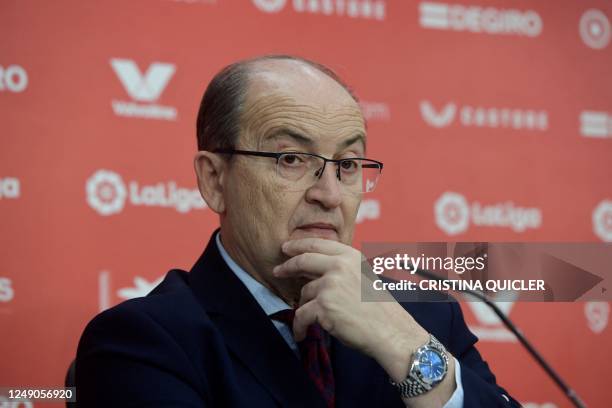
<box><xmin>415</xmin><ymin>268</ymin><xmax>586</xmax><ymax>408</ymax></box>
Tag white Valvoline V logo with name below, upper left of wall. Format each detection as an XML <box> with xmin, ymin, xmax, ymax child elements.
<box><xmin>110</xmin><ymin>58</ymin><xmax>177</xmax><ymax>120</ymax></box>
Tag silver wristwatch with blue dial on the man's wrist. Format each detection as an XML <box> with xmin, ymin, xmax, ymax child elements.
<box><xmin>389</xmin><ymin>334</ymin><xmax>448</xmax><ymax>398</ymax></box>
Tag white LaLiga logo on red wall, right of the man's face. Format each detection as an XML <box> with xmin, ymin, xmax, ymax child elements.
<box><xmin>434</xmin><ymin>191</ymin><xmax>542</xmax><ymax>236</ymax></box>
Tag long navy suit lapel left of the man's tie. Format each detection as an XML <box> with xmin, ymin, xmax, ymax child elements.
<box><xmin>189</xmin><ymin>231</ymin><xmax>325</xmax><ymax>407</ymax></box>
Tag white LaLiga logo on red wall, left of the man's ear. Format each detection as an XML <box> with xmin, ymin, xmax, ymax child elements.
<box><xmin>85</xmin><ymin>169</ymin><xmax>206</xmax><ymax>216</ymax></box>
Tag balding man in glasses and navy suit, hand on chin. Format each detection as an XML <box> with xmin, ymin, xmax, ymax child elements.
<box><xmin>76</xmin><ymin>56</ymin><xmax>517</xmax><ymax>408</ymax></box>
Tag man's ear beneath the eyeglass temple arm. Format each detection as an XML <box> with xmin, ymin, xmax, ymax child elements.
<box><xmin>193</xmin><ymin>150</ymin><xmax>227</xmax><ymax>214</ymax></box>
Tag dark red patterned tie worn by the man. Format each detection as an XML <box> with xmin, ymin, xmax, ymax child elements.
<box><xmin>271</xmin><ymin>309</ymin><xmax>336</xmax><ymax>408</ymax></box>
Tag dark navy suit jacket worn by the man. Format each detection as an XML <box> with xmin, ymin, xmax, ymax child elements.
<box><xmin>76</xmin><ymin>234</ymin><xmax>516</xmax><ymax>408</ymax></box>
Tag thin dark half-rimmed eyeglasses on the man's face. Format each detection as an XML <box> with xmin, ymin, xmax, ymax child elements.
<box><xmin>213</xmin><ymin>149</ymin><xmax>383</xmax><ymax>194</ymax></box>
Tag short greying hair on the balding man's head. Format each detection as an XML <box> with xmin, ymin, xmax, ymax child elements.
<box><xmin>196</xmin><ymin>55</ymin><xmax>359</xmax><ymax>151</ymax></box>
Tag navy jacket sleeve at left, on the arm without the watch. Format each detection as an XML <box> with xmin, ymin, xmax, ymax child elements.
<box><xmin>75</xmin><ymin>307</ymin><xmax>210</xmax><ymax>408</ymax></box>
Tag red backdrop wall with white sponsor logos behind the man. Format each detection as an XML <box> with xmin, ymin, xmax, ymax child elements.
<box><xmin>0</xmin><ymin>0</ymin><xmax>612</xmax><ymax>408</ymax></box>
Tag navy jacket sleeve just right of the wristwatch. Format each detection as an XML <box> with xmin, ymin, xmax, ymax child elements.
<box><xmin>449</xmin><ymin>302</ymin><xmax>521</xmax><ymax>408</ymax></box>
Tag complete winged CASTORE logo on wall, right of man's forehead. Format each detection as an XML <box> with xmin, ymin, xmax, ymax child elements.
<box><xmin>419</xmin><ymin>100</ymin><xmax>548</xmax><ymax>131</ymax></box>
